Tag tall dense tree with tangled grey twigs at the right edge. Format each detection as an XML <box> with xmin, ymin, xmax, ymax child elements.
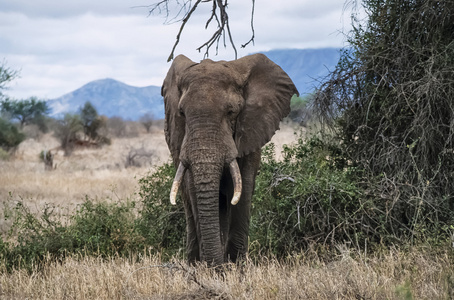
<box><xmin>315</xmin><ymin>0</ymin><xmax>454</xmax><ymax>236</ymax></box>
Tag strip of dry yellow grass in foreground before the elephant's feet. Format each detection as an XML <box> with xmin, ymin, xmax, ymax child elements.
<box><xmin>0</xmin><ymin>250</ymin><xmax>454</xmax><ymax>299</ymax></box>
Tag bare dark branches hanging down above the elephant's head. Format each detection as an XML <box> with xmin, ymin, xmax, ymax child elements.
<box><xmin>150</xmin><ymin>0</ymin><xmax>255</xmax><ymax>61</ymax></box>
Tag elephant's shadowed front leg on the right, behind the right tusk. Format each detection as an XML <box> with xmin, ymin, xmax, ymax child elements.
<box><xmin>227</xmin><ymin>150</ymin><xmax>261</xmax><ymax>262</ymax></box>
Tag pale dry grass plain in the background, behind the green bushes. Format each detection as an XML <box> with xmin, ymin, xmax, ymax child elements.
<box><xmin>0</xmin><ymin>125</ymin><xmax>302</xmax><ymax>211</ymax></box>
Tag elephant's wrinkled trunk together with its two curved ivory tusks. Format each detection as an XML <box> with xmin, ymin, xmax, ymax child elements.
<box><xmin>171</xmin><ymin>120</ymin><xmax>242</xmax><ymax>266</ymax></box>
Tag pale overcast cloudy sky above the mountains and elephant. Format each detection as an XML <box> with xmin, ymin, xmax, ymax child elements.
<box><xmin>0</xmin><ymin>0</ymin><xmax>350</xmax><ymax>99</ymax></box>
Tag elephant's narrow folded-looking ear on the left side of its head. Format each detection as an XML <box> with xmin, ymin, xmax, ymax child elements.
<box><xmin>161</xmin><ymin>55</ymin><xmax>195</xmax><ymax>162</ymax></box>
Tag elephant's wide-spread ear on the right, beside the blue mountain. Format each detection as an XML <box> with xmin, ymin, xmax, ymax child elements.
<box><xmin>228</xmin><ymin>54</ymin><xmax>298</xmax><ymax>157</ymax></box>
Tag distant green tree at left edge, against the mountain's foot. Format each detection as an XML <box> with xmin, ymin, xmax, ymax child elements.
<box><xmin>0</xmin><ymin>97</ymin><xmax>50</xmax><ymax>128</ymax></box>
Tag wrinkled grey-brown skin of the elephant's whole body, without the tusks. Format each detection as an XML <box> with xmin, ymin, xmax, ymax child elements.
<box><xmin>162</xmin><ymin>54</ymin><xmax>298</xmax><ymax>266</ymax></box>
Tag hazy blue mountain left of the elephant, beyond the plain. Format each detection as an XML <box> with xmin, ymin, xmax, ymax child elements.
<box><xmin>48</xmin><ymin>79</ymin><xmax>164</xmax><ymax>120</ymax></box>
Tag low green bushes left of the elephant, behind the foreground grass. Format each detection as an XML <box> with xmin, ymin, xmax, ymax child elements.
<box><xmin>0</xmin><ymin>164</ymin><xmax>186</xmax><ymax>270</ymax></box>
